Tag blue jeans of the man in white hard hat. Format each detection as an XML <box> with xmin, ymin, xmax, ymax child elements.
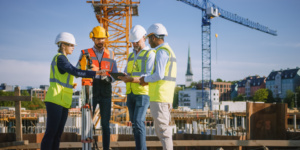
<box><xmin>127</xmin><ymin>92</ymin><xmax>150</xmax><ymax>150</ymax></box>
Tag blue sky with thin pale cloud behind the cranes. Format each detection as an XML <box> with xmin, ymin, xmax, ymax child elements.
<box><xmin>0</xmin><ymin>0</ymin><xmax>300</xmax><ymax>88</ymax></box>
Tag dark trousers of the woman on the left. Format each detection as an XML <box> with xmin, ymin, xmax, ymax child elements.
<box><xmin>41</xmin><ymin>102</ymin><xmax>69</xmax><ymax>150</ymax></box>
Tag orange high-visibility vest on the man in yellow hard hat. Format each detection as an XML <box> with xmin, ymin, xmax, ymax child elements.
<box><xmin>82</xmin><ymin>48</ymin><xmax>114</xmax><ymax>75</ymax></box>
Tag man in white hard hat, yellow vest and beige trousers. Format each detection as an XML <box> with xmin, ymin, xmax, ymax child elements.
<box><xmin>140</xmin><ymin>23</ymin><xmax>177</xmax><ymax>150</ymax></box>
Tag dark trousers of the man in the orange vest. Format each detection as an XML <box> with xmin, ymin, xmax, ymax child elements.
<box><xmin>93</xmin><ymin>96</ymin><xmax>111</xmax><ymax>150</ymax></box>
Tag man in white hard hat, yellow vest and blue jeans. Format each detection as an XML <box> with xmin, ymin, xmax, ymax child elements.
<box><xmin>118</xmin><ymin>25</ymin><xmax>155</xmax><ymax>150</ymax></box>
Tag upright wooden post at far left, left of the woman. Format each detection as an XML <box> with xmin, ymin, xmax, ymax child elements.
<box><xmin>15</xmin><ymin>87</ymin><xmax>23</xmax><ymax>141</ymax></box>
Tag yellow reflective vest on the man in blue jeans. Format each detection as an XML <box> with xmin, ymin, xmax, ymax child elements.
<box><xmin>126</xmin><ymin>50</ymin><xmax>155</xmax><ymax>95</ymax></box>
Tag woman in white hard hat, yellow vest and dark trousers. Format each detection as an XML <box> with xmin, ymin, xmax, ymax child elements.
<box><xmin>41</xmin><ymin>32</ymin><xmax>105</xmax><ymax>150</ymax></box>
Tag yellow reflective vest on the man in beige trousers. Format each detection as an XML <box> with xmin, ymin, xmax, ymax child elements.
<box><xmin>149</xmin><ymin>45</ymin><xmax>177</xmax><ymax>103</ymax></box>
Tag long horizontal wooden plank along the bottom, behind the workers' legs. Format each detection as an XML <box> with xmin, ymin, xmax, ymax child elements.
<box><xmin>5</xmin><ymin>140</ymin><xmax>300</xmax><ymax>149</ymax></box>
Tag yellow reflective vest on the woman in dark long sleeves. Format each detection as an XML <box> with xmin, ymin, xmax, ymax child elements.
<box><xmin>45</xmin><ymin>53</ymin><xmax>74</xmax><ymax>108</ymax></box>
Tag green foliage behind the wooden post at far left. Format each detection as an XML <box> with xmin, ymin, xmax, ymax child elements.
<box><xmin>0</xmin><ymin>91</ymin><xmax>46</xmax><ymax>110</ymax></box>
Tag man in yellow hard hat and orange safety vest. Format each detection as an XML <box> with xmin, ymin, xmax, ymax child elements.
<box><xmin>77</xmin><ymin>26</ymin><xmax>118</xmax><ymax>150</ymax></box>
